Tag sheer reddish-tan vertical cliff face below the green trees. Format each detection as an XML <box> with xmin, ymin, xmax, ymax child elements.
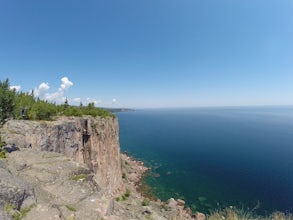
<box><xmin>0</xmin><ymin>117</ymin><xmax>123</xmax><ymax>195</ymax></box>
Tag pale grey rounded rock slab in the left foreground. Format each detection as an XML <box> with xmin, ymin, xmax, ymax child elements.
<box><xmin>0</xmin><ymin>149</ymin><xmax>114</xmax><ymax>220</ymax></box>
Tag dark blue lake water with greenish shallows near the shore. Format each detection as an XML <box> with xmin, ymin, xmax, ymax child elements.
<box><xmin>117</xmin><ymin>107</ymin><xmax>293</xmax><ymax>214</ymax></box>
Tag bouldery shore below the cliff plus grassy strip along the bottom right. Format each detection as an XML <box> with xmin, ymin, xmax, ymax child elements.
<box><xmin>117</xmin><ymin>153</ymin><xmax>293</xmax><ymax>220</ymax></box>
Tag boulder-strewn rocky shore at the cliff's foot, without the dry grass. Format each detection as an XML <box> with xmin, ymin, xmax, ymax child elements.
<box><xmin>114</xmin><ymin>153</ymin><xmax>205</xmax><ymax>220</ymax></box>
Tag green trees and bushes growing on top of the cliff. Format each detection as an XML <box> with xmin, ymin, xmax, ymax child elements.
<box><xmin>0</xmin><ymin>79</ymin><xmax>115</xmax><ymax>123</ymax></box>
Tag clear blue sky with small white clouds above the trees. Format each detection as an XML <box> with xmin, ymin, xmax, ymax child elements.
<box><xmin>0</xmin><ymin>0</ymin><xmax>293</xmax><ymax>108</ymax></box>
